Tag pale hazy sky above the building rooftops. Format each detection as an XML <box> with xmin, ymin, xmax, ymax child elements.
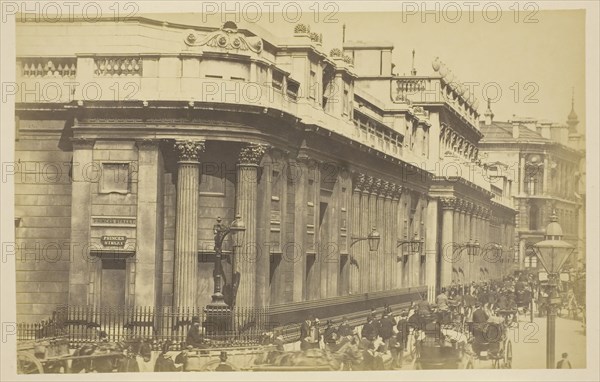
<box><xmin>152</xmin><ymin>3</ymin><xmax>586</xmax><ymax>128</ymax></box>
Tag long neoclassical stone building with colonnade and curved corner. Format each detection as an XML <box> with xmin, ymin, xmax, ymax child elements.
<box><xmin>15</xmin><ymin>18</ymin><xmax>517</xmax><ymax>321</ymax></box>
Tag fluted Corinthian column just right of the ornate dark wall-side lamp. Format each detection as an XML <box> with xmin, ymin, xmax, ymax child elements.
<box><xmin>234</xmin><ymin>143</ymin><xmax>269</xmax><ymax>307</ymax></box>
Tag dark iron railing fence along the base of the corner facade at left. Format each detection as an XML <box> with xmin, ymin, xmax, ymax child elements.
<box><xmin>17</xmin><ymin>306</ymin><xmax>272</xmax><ymax>349</ymax></box>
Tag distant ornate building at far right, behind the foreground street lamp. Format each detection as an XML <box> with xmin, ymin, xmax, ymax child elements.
<box><xmin>480</xmin><ymin>96</ymin><xmax>585</xmax><ymax>270</ymax></box>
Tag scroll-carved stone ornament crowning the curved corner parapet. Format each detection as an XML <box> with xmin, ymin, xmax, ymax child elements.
<box><xmin>185</xmin><ymin>21</ymin><xmax>263</xmax><ymax>53</ymax></box>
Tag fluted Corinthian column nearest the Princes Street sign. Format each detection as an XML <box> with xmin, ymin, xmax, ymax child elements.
<box><xmin>173</xmin><ymin>140</ymin><xmax>204</xmax><ymax>308</ymax></box>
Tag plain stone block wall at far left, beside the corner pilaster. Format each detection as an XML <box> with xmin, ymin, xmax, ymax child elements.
<box><xmin>14</xmin><ymin>117</ymin><xmax>72</xmax><ymax>322</ymax></box>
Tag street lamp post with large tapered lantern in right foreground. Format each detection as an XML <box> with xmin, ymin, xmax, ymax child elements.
<box><xmin>533</xmin><ymin>212</ymin><xmax>575</xmax><ymax>369</ymax></box>
